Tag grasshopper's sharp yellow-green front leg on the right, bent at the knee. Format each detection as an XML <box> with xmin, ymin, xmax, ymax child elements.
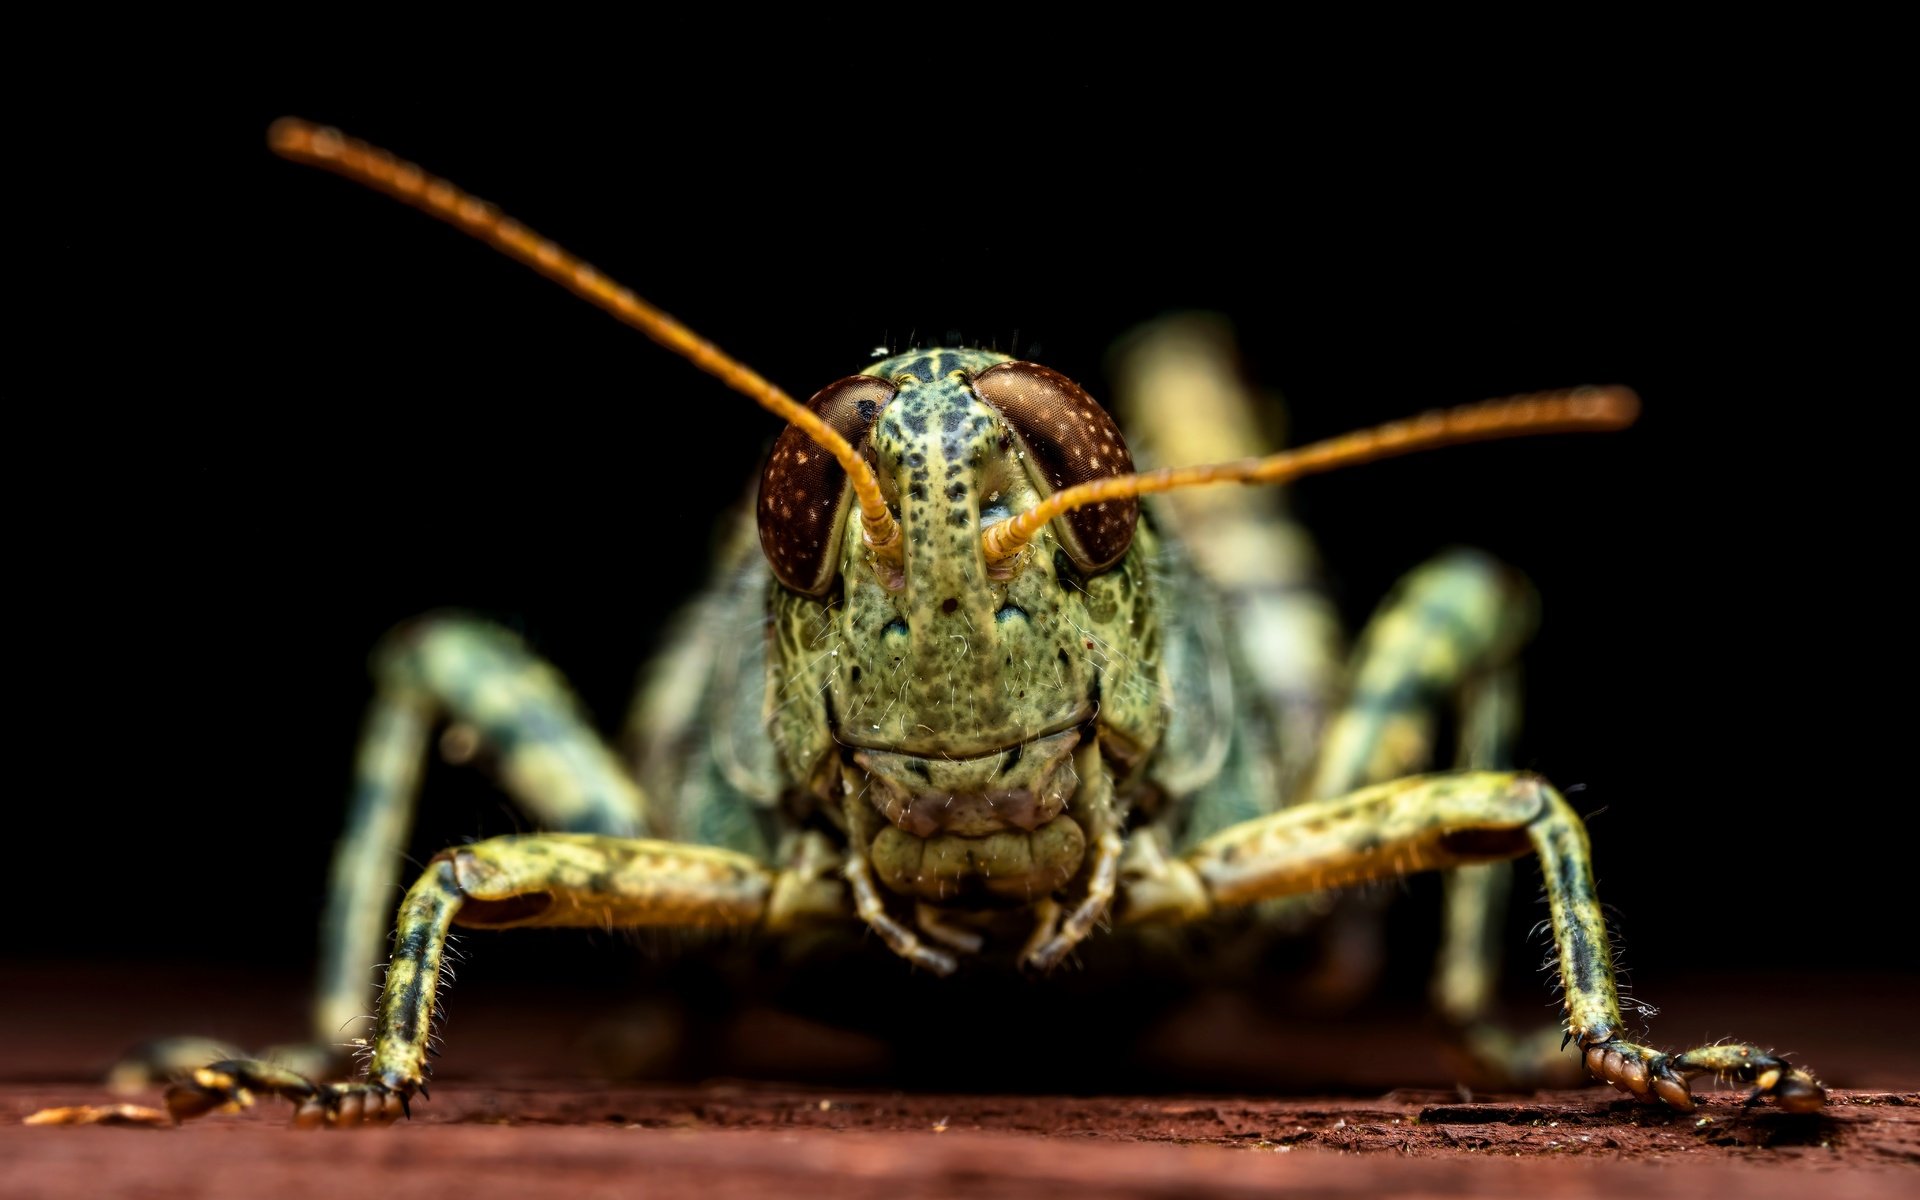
<box><xmin>1119</xmin><ymin>772</ymin><xmax>1826</xmax><ymax>1112</ymax></box>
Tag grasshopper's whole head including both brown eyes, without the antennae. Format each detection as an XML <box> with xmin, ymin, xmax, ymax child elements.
<box><xmin>760</xmin><ymin>351</ymin><xmax>1164</xmax><ymax>904</ymax></box>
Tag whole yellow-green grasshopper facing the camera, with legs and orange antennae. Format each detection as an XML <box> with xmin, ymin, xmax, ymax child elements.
<box><xmin>116</xmin><ymin>121</ymin><xmax>1824</xmax><ymax>1125</ymax></box>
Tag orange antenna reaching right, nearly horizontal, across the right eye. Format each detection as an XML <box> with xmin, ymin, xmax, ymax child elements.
<box><xmin>981</xmin><ymin>388</ymin><xmax>1640</xmax><ymax>566</ymax></box>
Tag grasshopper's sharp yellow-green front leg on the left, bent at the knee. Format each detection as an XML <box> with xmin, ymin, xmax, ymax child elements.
<box><xmin>167</xmin><ymin>833</ymin><xmax>794</xmax><ymax>1125</ymax></box>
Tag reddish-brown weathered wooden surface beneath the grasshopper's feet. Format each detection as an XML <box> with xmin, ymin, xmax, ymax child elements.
<box><xmin>0</xmin><ymin>1083</ymin><xmax>1920</xmax><ymax>1198</ymax></box>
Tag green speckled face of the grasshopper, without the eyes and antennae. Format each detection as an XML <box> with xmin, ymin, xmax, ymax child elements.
<box><xmin>768</xmin><ymin>349</ymin><xmax>1164</xmax><ymax>899</ymax></box>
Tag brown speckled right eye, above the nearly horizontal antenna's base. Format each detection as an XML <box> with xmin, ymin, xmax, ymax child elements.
<box><xmin>973</xmin><ymin>363</ymin><xmax>1140</xmax><ymax>574</ymax></box>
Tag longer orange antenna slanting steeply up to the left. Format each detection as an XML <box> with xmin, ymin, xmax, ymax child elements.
<box><xmin>267</xmin><ymin>117</ymin><xmax>904</xmax><ymax>566</ymax></box>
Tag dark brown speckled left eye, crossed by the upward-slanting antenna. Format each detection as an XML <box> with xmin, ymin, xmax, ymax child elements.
<box><xmin>758</xmin><ymin>374</ymin><xmax>895</xmax><ymax>595</ymax></box>
